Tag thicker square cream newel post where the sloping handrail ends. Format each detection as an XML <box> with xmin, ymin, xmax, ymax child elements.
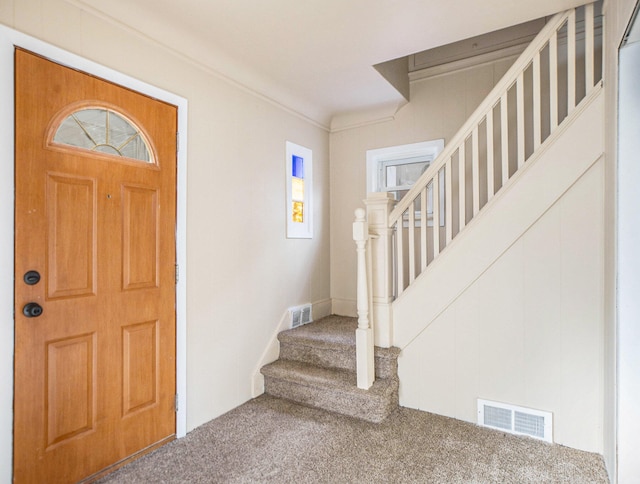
<box><xmin>365</xmin><ymin>192</ymin><xmax>396</xmax><ymax>348</ymax></box>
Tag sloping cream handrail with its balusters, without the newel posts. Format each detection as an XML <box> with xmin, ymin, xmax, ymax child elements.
<box><xmin>384</xmin><ymin>2</ymin><xmax>602</xmax><ymax>297</ymax></box>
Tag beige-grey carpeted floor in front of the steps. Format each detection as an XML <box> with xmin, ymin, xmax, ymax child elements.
<box><xmin>99</xmin><ymin>395</ymin><xmax>608</xmax><ymax>484</ymax></box>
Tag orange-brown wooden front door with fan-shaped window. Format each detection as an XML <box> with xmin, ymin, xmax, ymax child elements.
<box><xmin>14</xmin><ymin>50</ymin><xmax>177</xmax><ymax>483</ymax></box>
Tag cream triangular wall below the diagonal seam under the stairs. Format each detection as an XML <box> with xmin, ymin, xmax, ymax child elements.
<box><xmin>399</xmin><ymin>162</ymin><xmax>603</xmax><ymax>453</ymax></box>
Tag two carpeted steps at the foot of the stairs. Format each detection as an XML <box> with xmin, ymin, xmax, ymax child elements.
<box><xmin>261</xmin><ymin>316</ymin><xmax>400</xmax><ymax>423</ymax></box>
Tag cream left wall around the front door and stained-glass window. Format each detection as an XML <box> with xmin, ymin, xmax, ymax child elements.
<box><xmin>0</xmin><ymin>0</ymin><xmax>329</xmax><ymax>482</ymax></box>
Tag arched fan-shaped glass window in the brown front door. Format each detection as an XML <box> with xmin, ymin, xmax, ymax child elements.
<box><xmin>53</xmin><ymin>107</ymin><xmax>154</xmax><ymax>163</ymax></box>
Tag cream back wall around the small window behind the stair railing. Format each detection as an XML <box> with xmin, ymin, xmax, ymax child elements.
<box><xmin>330</xmin><ymin>57</ymin><xmax>515</xmax><ymax>315</ymax></box>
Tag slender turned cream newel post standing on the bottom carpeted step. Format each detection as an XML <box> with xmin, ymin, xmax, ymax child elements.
<box><xmin>353</xmin><ymin>208</ymin><xmax>375</xmax><ymax>390</ymax></box>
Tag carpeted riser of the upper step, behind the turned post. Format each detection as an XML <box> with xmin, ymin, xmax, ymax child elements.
<box><xmin>280</xmin><ymin>342</ymin><xmax>398</xmax><ymax>379</ymax></box>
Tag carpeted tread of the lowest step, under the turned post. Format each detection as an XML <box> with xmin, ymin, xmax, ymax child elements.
<box><xmin>261</xmin><ymin>360</ymin><xmax>398</xmax><ymax>396</ymax></box>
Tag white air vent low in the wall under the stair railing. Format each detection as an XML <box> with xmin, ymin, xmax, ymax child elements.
<box><xmin>478</xmin><ymin>399</ymin><xmax>553</xmax><ymax>442</ymax></box>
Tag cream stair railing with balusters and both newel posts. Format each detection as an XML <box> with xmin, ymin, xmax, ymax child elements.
<box><xmin>353</xmin><ymin>1</ymin><xmax>602</xmax><ymax>388</ymax></box>
